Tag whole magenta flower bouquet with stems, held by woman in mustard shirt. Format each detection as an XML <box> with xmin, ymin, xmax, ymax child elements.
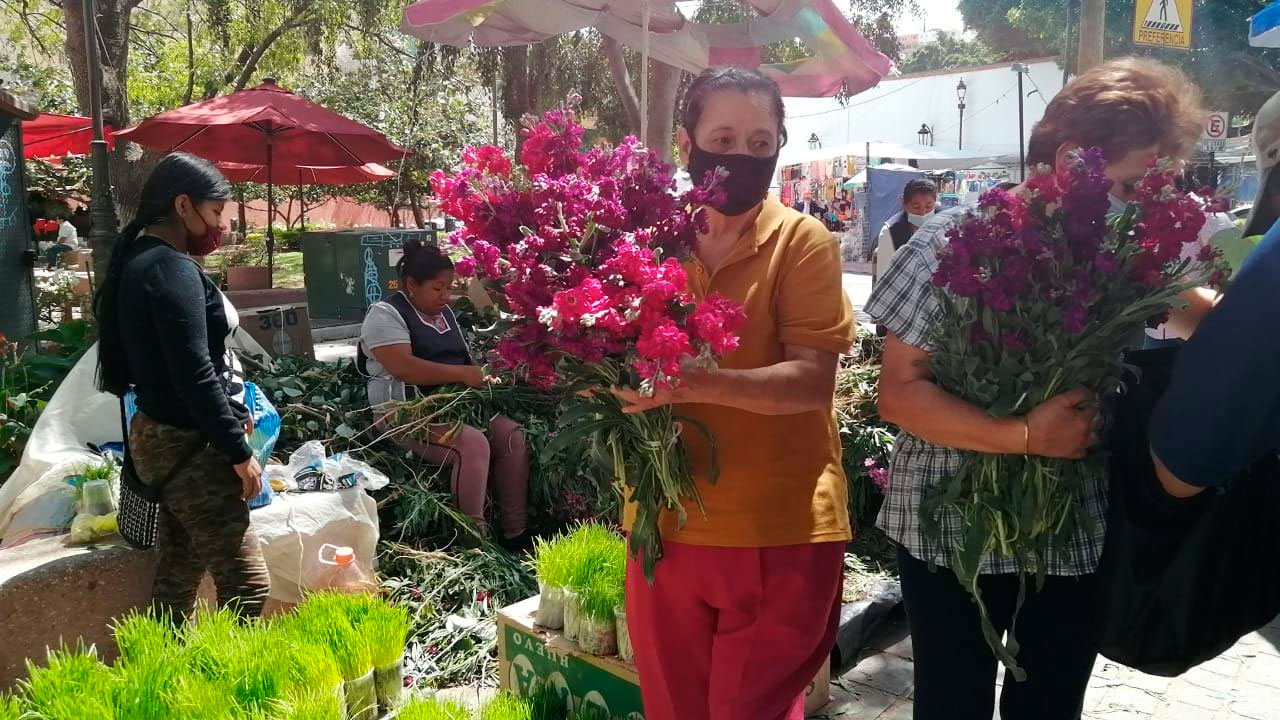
<box><xmin>431</xmin><ymin>99</ymin><xmax>746</xmax><ymax>578</ymax></box>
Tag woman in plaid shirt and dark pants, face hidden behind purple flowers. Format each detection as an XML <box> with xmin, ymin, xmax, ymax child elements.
<box><xmin>867</xmin><ymin>58</ymin><xmax>1212</xmax><ymax>720</ymax></box>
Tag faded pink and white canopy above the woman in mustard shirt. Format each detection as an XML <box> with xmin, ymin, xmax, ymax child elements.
<box><xmin>401</xmin><ymin>0</ymin><xmax>893</xmax><ymax>97</ymax></box>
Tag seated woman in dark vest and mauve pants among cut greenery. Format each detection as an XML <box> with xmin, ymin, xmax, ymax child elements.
<box><xmin>356</xmin><ymin>241</ymin><xmax>530</xmax><ymax>551</ymax></box>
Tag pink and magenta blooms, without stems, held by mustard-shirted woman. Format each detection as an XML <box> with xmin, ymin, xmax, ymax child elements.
<box><xmin>431</xmin><ymin>99</ymin><xmax>745</xmax><ymax>392</ymax></box>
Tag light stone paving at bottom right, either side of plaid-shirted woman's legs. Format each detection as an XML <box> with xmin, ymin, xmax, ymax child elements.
<box><xmin>812</xmin><ymin>609</ymin><xmax>1280</xmax><ymax>720</ymax></box>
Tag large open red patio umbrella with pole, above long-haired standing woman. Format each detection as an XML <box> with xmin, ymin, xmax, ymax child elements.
<box><xmin>115</xmin><ymin>78</ymin><xmax>410</xmax><ymax>280</ymax></box>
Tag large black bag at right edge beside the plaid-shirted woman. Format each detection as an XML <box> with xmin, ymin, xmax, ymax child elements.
<box><xmin>1094</xmin><ymin>348</ymin><xmax>1280</xmax><ymax>676</ymax></box>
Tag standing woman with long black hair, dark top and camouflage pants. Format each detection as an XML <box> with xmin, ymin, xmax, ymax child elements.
<box><xmin>96</xmin><ymin>152</ymin><xmax>269</xmax><ymax>623</ymax></box>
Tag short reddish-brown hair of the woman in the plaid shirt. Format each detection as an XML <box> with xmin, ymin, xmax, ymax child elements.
<box><xmin>1027</xmin><ymin>58</ymin><xmax>1207</xmax><ymax>165</ymax></box>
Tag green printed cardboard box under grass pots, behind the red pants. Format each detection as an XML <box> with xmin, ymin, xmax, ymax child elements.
<box><xmin>488</xmin><ymin>597</ymin><xmax>831</xmax><ymax>720</ymax></box>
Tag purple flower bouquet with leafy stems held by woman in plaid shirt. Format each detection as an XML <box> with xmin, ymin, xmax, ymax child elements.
<box><xmin>920</xmin><ymin>147</ymin><xmax>1224</xmax><ymax>676</ymax></box>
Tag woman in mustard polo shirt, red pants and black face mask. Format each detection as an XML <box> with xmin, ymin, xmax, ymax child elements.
<box><xmin>616</xmin><ymin>68</ymin><xmax>854</xmax><ymax>720</ymax></box>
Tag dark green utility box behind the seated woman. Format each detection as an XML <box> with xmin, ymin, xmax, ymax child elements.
<box><xmin>301</xmin><ymin>228</ymin><xmax>436</xmax><ymax>323</ymax></box>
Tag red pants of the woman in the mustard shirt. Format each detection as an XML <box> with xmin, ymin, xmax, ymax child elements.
<box><xmin>627</xmin><ymin>542</ymin><xmax>845</xmax><ymax>720</ymax></box>
